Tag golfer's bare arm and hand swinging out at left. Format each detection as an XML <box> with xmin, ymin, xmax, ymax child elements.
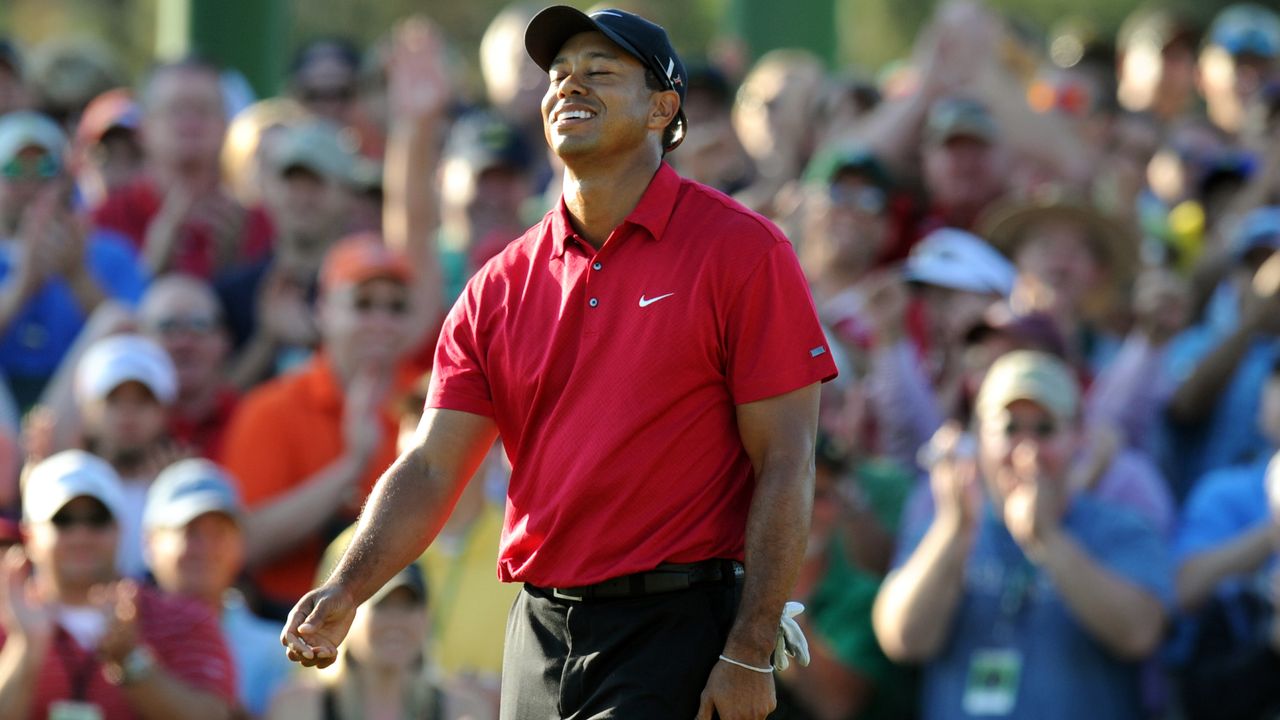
<box><xmin>280</xmin><ymin>409</ymin><xmax>498</xmax><ymax>667</ymax></box>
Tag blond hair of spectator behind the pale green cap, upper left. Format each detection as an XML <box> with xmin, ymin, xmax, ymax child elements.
<box><xmin>223</xmin><ymin>97</ymin><xmax>311</xmax><ymax>211</ymax></box>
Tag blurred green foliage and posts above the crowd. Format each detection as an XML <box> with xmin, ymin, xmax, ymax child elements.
<box><xmin>0</xmin><ymin>0</ymin><xmax>1259</xmax><ymax>92</ymax></box>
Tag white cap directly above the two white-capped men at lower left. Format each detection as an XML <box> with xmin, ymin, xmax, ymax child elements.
<box><xmin>76</xmin><ymin>334</ymin><xmax>178</xmax><ymax>405</ymax></box>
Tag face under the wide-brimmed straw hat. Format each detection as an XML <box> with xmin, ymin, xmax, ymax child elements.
<box><xmin>1015</xmin><ymin>220</ymin><xmax>1102</xmax><ymax>310</ymax></box>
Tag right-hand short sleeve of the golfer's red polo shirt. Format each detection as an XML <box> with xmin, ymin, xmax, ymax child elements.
<box><xmin>724</xmin><ymin>242</ymin><xmax>836</xmax><ymax>405</ymax></box>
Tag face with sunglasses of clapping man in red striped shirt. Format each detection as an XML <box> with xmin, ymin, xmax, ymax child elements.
<box><xmin>27</xmin><ymin>496</ymin><xmax>120</xmax><ymax>588</ymax></box>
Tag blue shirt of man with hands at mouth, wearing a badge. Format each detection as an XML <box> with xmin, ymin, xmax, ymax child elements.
<box><xmin>899</xmin><ymin>497</ymin><xmax>1172</xmax><ymax>720</ymax></box>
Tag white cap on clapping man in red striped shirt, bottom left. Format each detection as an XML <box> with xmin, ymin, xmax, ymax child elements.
<box><xmin>22</xmin><ymin>450</ymin><xmax>124</xmax><ymax>523</ymax></box>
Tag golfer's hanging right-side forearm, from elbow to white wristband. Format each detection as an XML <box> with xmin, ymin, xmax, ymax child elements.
<box><xmin>724</xmin><ymin>454</ymin><xmax>814</xmax><ymax>666</ymax></box>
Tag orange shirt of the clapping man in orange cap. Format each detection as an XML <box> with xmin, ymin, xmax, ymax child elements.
<box><xmin>223</xmin><ymin>354</ymin><xmax>415</xmax><ymax>605</ymax></box>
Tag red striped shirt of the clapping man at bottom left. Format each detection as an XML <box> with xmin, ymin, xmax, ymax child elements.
<box><xmin>0</xmin><ymin>585</ymin><xmax>236</xmax><ymax>720</ymax></box>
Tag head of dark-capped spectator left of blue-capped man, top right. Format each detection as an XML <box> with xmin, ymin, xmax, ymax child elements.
<box><xmin>1116</xmin><ymin>5</ymin><xmax>1199</xmax><ymax>122</ymax></box>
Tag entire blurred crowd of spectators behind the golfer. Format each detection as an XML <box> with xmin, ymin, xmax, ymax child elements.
<box><xmin>0</xmin><ymin>0</ymin><xmax>1280</xmax><ymax>720</ymax></box>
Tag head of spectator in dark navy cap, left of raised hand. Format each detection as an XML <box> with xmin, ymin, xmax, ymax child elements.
<box><xmin>289</xmin><ymin>37</ymin><xmax>360</xmax><ymax>127</ymax></box>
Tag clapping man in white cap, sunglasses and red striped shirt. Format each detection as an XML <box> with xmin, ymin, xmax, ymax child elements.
<box><xmin>0</xmin><ymin>450</ymin><xmax>236</xmax><ymax>720</ymax></box>
